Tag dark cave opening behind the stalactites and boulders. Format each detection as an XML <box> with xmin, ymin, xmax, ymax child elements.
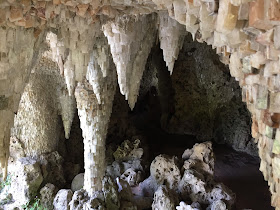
<box><xmin>107</xmin><ymin>37</ymin><xmax>273</xmax><ymax>210</ymax></box>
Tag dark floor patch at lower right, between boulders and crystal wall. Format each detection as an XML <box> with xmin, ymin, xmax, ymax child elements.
<box><xmin>214</xmin><ymin>145</ymin><xmax>274</xmax><ymax>210</ymax></box>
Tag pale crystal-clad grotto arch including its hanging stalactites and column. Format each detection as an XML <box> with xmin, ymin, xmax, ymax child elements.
<box><xmin>0</xmin><ymin>0</ymin><xmax>280</xmax><ymax>208</ymax></box>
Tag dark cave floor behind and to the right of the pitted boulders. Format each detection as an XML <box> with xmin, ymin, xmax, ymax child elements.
<box><xmin>138</xmin><ymin>120</ymin><xmax>274</xmax><ymax>210</ymax></box>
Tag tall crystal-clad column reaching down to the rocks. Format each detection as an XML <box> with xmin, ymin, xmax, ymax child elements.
<box><xmin>75</xmin><ymin>35</ymin><xmax>116</xmax><ymax>196</ymax></box>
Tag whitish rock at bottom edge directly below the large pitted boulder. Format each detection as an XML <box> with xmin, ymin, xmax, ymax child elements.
<box><xmin>152</xmin><ymin>186</ymin><xmax>178</xmax><ymax>210</ymax></box>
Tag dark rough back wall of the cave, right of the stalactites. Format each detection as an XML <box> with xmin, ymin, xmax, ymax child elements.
<box><xmin>165</xmin><ymin>36</ymin><xmax>257</xmax><ymax>155</ymax></box>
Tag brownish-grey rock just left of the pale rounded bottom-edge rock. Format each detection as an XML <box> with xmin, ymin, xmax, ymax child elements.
<box><xmin>40</xmin><ymin>183</ymin><xmax>57</xmax><ymax>209</ymax></box>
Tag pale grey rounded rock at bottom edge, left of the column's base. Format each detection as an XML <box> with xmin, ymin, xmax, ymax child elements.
<box><xmin>53</xmin><ymin>189</ymin><xmax>73</xmax><ymax>210</ymax></box>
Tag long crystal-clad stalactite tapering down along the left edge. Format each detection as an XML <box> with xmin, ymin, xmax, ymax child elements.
<box><xmin>0</xmin><ymin>27</ymin><xmax>43</xmax><ymax>177</ymax></box>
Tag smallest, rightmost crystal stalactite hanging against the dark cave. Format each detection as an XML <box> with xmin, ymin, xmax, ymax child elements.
<box><xmin>159</xmin><ymin>12</ymin><xmax>185</xmax><ymax>74</ymax></box>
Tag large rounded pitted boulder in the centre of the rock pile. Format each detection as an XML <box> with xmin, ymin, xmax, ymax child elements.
<box><xmin>150</xmin><ymin>155</ymin><xmax>181</xmax><ymax>189</ymax></box>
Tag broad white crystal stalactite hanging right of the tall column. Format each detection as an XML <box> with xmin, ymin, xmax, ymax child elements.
<box><xmin>103</xmin><ymin>14</ymin><xmax>156</xmax><ymax>109</ymax></box>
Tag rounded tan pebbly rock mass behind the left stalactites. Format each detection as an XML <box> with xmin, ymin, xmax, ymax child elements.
<box><xmin>13</xmin><ymin>57</ymin><xmax>75</xmax><ymax>157</ymax></box>
